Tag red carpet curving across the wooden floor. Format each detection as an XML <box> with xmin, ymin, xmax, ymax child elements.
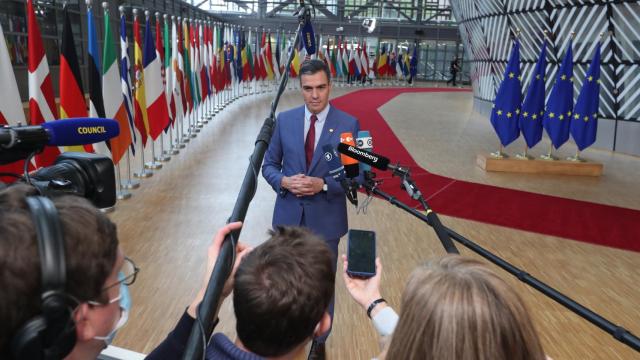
<box><xmin>331</xmin><ymin>88</ymin><xmax>640</xmax><ymax>251</ymax></box>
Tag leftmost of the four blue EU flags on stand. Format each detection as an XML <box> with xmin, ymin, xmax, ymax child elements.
<box><xmin>491</xmin><ymin>40</ymin><xmax>522</xmax><ymax>146</ymax></box>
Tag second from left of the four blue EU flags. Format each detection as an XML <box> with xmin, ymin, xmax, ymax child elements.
<box><xmin>519</xmin><ymin>40</ymin><xmax>547</xmax><ymax>148</ymax></box>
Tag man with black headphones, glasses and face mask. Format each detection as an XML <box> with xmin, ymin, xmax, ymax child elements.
<box><xmin>0</xmin><ymin>185</ymin><xmax>138</xmax><ymax>359</ymax></box>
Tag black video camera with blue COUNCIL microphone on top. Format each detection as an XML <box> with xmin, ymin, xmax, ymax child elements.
<box><xmin>0</xmin><ymin>119</ymin><xmax>120</xmax><ymax>208</ymax></box>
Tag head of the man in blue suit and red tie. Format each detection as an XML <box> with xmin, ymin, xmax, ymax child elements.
<box><xmin>300</xmin><ymin>59</ymin><xmax>331</xmax><ymax>114</ymax></box>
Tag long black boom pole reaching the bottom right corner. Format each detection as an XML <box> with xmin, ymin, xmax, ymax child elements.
<box><xmin>364</xmin><ymin>176</ymin><xmax>640</xmax><ymax>351</ymax></box>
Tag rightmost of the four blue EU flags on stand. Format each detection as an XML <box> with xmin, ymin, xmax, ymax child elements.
<box><xmin>571</xmin><ymin>43</ymin><xmax>600</xmax><ymax>151</ymax></box>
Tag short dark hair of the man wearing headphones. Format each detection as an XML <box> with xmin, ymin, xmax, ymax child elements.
<box><xmin>0</xmin><ymin>185</ymin><xmax>118</xmax><ymax>359</ymax></box>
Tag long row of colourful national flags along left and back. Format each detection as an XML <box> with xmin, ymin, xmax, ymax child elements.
<box><xmin>0</xmin><ymin>0</ymin><xmax>418</xmax><ymax>180</ymax></box>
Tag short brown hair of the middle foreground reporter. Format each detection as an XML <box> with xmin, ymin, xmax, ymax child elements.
<box><xmin>233</xmin><ymin>227</ymin><xmax>335</xmax><ymax>357</ymax></box>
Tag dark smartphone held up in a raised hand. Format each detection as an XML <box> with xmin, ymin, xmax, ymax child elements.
<box><xmin>347</xmin><ymin>229</ymin><xmax>376</xmax><ymax>278</ymax></box>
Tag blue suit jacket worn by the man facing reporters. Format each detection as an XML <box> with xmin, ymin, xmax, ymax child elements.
<box><xmin>262</xmin><ymin>106</ymin><xmax>360</xmax><ymax>240</ymax></box>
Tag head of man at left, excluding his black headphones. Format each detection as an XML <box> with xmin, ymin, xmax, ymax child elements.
<box><xmin>0</xmin><ymin>185</ymin><xmax>130</xmax><ymax>359</ymax></box>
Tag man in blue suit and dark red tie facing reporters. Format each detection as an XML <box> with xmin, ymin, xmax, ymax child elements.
<box><xmin>262</xmin><ymin>60</ymin><xmax>360</xmax><ymax>358</ymax></box>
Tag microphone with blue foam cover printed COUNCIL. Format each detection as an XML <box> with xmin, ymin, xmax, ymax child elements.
<box><xmin>0</xmin><ymin>118</ymin><xmax>120</xmax><ymax>164</ymax></box>
